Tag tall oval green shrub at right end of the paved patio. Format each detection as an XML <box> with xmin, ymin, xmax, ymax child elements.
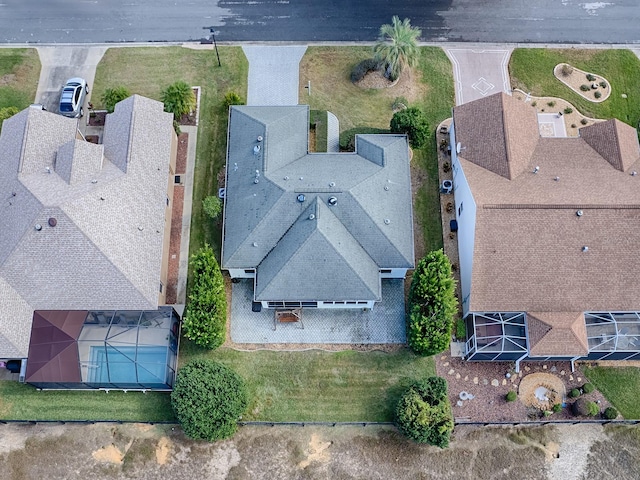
<box><xmin>408</xmin><ymin>249</ymin><xmax>458</xmax><ymax>355</ymax></box>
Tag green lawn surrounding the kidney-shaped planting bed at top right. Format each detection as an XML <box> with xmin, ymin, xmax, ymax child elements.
<box><xmin>509</xmin><ymin>48</ymin><xmax>640</xmax><ymax>127</ymax></box>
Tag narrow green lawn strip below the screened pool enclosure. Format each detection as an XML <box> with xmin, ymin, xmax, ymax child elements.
<box><xmin>0</xmin><ymin>380</ymin><xmax>175</xmax><ymax>422</ymax></box>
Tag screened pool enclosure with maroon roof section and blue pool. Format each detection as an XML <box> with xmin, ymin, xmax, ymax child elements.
<box><xmin>25</xmin><ymin>307</ymin><xmax>180</xmax><ymax>391</ymax></box>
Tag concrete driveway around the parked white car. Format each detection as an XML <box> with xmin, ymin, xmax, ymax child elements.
<box><xmin>34</xmin><ymin>46</ymin><xmax>107</xmax><ymax>133</ymax></box>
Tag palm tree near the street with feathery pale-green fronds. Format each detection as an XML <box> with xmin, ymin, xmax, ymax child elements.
<box><xmin>373</xmin><ymin>15</ymin><xmax>422</xmax><ymax>80</ymax></box>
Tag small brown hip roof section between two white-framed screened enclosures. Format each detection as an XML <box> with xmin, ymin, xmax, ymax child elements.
<box><xmin>527</xmin><ymin>312</ymin><xmax>589</xmax><ymax>357</ymax></box>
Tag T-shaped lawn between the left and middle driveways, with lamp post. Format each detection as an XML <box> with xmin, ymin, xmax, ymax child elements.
<box><xmin>92</xmin><ymin>47</ymin><xmax>249</xmax><ymax>257</ymax></box>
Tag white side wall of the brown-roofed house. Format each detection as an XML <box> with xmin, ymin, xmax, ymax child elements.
<box><xmin>451</xmin><ymin>124</ymin><xmax>477</xmax><ymax>315</ymax></box>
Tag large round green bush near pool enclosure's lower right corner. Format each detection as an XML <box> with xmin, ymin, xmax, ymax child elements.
<box><xmin>171</xmin><ymin>359</ymin><xmax>247</xmax><ymax>442</ymax></box>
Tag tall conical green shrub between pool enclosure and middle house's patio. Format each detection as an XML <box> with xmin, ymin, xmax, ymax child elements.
<box><xmin>182</xmin><ymin>245</ymin><xmax>227</xmax><ymax>349</ymax></box>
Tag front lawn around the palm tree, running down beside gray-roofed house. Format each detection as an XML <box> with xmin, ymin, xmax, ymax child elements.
<box><xmin>299</xmin><ymin>47</ymin><xmax>454</xmax><ymax>252</ymax></box>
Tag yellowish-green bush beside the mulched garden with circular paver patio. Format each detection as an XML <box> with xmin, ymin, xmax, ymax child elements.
<box><xmin>396</xmin><ymin>377</ymin><xmax>453</xmax><ymax>448</ymax></box>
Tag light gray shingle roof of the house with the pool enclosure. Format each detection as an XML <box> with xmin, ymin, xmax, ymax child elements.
<box><xmin>0</xmin><ymin>96</ymin><xmax>175</xmax><ymax>357</ymax></box>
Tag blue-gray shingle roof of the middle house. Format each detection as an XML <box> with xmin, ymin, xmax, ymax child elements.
<box><xmin>222</xmin><ymin>106</ymin><xmax>414</xmax><ymax>301</ymax></box>
